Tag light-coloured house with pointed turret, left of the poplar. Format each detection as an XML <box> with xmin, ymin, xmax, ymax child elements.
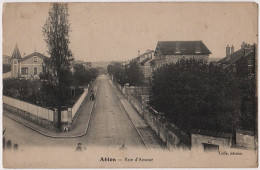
<box><xmin>11</xmin><ymin>44</ymin><xmax>48</xmax><ymax>78</ymax></box>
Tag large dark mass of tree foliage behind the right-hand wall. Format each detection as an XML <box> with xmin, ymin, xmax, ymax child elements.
<box><xmin>150</xmin><ymin>59</ymin><xmax>255</xmax><ymax>132</ymax></box>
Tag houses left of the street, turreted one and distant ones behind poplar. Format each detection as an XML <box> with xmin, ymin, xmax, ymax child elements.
<box><xmin>2</xmin><ymin>44</ymin><xmax>91</xmax><ymax>78</ymax></box>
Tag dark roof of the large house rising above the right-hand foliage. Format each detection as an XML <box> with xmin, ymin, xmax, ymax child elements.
<box><xmin>155</xmin><ymin>41</ymin><xmax>211</xmax><ymax>55</ymax></box>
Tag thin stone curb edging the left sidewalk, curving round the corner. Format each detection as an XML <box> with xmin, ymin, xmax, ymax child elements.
<box><xmin>3</xmin><ymin>82</ymin><xmax>98</xmax><ymax>138</ymax></box>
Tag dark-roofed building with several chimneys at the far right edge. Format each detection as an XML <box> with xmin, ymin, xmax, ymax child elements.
<box><xmin>218</xmin><ymin>42</ymin><xmax>256</xmax><ymax>74</ymax></box>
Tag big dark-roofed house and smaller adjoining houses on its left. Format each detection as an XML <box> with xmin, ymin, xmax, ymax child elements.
<box><xmin>122</xmin><ymin>41</ymin><xmax>211</xmax><ymax>81</ymax></box>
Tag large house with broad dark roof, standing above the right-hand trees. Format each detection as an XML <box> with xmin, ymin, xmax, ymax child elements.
<box><xmin>152</xmin><ymin>41</ymin><xmax>212</xmax><ymax>69</ymax></box>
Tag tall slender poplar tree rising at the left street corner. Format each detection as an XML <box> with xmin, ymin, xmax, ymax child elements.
<box><xmin>43</xmin><ymin>3</ymin><xmax>73</xmax><ymax>128</ymax></box>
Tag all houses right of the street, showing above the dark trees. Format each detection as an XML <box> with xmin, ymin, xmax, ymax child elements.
<box><xmin>122</xmin><ymin>41</ymin><xmax>256</xmax><ymax>82</ymax></box>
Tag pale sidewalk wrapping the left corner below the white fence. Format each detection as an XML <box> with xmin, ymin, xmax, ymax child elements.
<box><xmin>3</xmin><ymin>81</ymin><xmax>98</xmax><ymax>138</ymax></box>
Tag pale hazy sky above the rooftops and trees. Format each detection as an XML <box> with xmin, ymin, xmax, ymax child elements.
<box><xmin>2</xmin><ymin>2</ymin><xmax>257</xmax><ymax>62</ymax></box>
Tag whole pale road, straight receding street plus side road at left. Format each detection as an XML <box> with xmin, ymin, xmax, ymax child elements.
<box><xmin>3</xmin><ymin>75</ymin><xmax>160</xmax><ymax>149</ymax></box>
